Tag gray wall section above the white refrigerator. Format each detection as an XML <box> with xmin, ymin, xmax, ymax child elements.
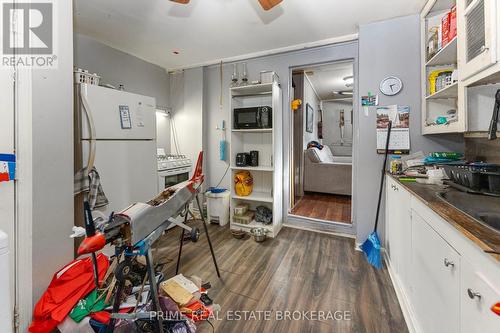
<box><xmin>74</xmin><ymin>33</ymin><xmax>169</xmax><ymax>107</ymax></box>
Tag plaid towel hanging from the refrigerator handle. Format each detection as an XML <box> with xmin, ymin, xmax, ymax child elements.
<box><xmin>74</xmin><ymin>167</ymin><xmax>109</xmax><ymax>210</ymax></box>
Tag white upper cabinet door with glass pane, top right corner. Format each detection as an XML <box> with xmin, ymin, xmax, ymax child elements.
<box><xmin>458</xmin><ymin>0</ymin><xmax>499</xmax><ymax>79</ymax></box>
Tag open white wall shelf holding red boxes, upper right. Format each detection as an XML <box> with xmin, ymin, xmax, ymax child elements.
<box><xmin>421</xmin><ymin>0</ymin><xmax>467</xmax><ymax>134</ymax></box>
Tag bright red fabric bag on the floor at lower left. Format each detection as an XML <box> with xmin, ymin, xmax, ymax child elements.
<box><xmin>29</xmin><ymin>253</ymin><xmax>109</xmax><ymax>333</ymax></box>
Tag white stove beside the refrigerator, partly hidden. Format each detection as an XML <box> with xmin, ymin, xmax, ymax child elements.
<box><xmin>156</xmin><ymin>148</ymin><xmax>192</xmax><ymax>190</ymax></box>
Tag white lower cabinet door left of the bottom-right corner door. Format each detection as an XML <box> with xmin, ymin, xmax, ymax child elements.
<box><xmin>412</xmin><ymin>212</ymin><xmax>460</xmax><ymax>333</ymax></box>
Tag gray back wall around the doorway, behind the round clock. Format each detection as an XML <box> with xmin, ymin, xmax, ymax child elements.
<box><xmin>191</xmin><ymin>15</ymin><xmax>463</xmax><ymax>242</ymax></box>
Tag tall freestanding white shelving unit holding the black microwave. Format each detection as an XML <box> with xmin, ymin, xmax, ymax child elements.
<box><xmin>229</xmin><ymin>83</ymin><xmax>283</xmax><ymax>237</ymax></box>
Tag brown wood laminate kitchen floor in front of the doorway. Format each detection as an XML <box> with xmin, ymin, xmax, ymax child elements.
<box><xmin>155</xmin><ymin>222</ymin><xmax>408</xmax><ymax>333</ymax></box>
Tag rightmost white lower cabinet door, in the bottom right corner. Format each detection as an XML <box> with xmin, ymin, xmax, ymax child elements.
<box><xmin>460</xmin><ymin>258</ymin><xmax>500</xmax><ymax>333</ymax></box>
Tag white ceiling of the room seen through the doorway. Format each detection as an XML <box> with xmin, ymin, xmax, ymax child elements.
<box><xmin>303</xmin><ymin>62</ymin><xmax>354</xmax><ymax>101</ymax></box>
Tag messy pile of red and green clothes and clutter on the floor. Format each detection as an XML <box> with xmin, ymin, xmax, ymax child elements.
<box><xmin>29</xmin><ymin>254</ymin><xmax>214</xmax><ymax>333</ymax></box>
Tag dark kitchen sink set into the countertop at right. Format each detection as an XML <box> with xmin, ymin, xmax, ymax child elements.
<box><xmin>437</xmin><ymin>189</ymin><xmax>500</xmax><ymax>233</ymax></box>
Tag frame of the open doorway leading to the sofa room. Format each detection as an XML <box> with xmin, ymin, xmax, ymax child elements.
<box><xmin>283</xmin><ymin>57</ymin><xmax>359</xmax><ymax>237</ymax></box>
